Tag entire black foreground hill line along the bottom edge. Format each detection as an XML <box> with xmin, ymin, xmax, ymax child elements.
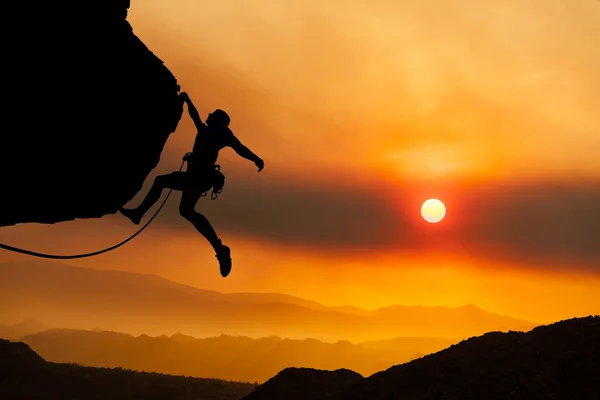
<box><xmin>0</xmin><ymin>316</ymin><xmax>600</xmax><ymax>400</ymax></box>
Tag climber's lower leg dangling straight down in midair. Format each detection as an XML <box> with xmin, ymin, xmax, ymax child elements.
<box><xmin>179</xmin><ymin>188</ymin><xmax>231</xmax><ymax>277</ymax></box>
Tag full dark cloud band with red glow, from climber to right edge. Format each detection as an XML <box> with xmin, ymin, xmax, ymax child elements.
<box><xmin>141</xmin><ymin>160</ymin><xmax>600</xmax><ymax>271</ymax></box>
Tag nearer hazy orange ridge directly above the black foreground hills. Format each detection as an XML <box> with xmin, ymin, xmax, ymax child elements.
<box><xmin>20</xmin><ymin>329</ymin><xmax>457</xmax><ymax>382</ymax></box>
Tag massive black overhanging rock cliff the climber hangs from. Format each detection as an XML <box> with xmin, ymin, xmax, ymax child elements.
<box><xmin>0</xmin><ymin>0</ymin><xmax>183</xmax><ymax>226</ymax></box>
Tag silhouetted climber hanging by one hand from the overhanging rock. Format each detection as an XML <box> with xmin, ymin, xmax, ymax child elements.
<box><xmin>119</xmin><ymin>92</ymin><xmax>265</xmax><ymax>277</ymax></box>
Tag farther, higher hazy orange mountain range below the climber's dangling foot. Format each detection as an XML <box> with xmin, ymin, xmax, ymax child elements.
<box><xmin>0</xmin><ymin>261</ymin><xmax>537</xmax><ymax>343</ymax></box>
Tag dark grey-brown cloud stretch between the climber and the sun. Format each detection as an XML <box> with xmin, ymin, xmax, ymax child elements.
<box><xmin>148</xmin><ymin>166</ymin><xmax>408</xmax><ymax>250</ymax></box>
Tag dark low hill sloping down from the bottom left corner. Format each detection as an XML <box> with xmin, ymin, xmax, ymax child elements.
<box><xmin>0</xmin><ymin>340</ymin><xmax>254</xmax><ymax>400</ymax></box>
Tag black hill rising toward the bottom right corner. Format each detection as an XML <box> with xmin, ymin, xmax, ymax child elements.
<box><xmin>244</xmin><ymin>316</ymin><xmax>600</xmax><ymax>400</ymax></box>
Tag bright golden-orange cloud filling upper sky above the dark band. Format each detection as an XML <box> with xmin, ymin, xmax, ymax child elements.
<box><xmin>130</xmin><ymin>0</ymin><xmax>600</xmax><ymax>180</ymax></box>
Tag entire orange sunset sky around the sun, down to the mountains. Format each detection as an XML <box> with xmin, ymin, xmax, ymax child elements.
<box><xmin>0</xmin><ymin>0</ymin><xmax>600</xmax><ymax>322</ymax></box>
